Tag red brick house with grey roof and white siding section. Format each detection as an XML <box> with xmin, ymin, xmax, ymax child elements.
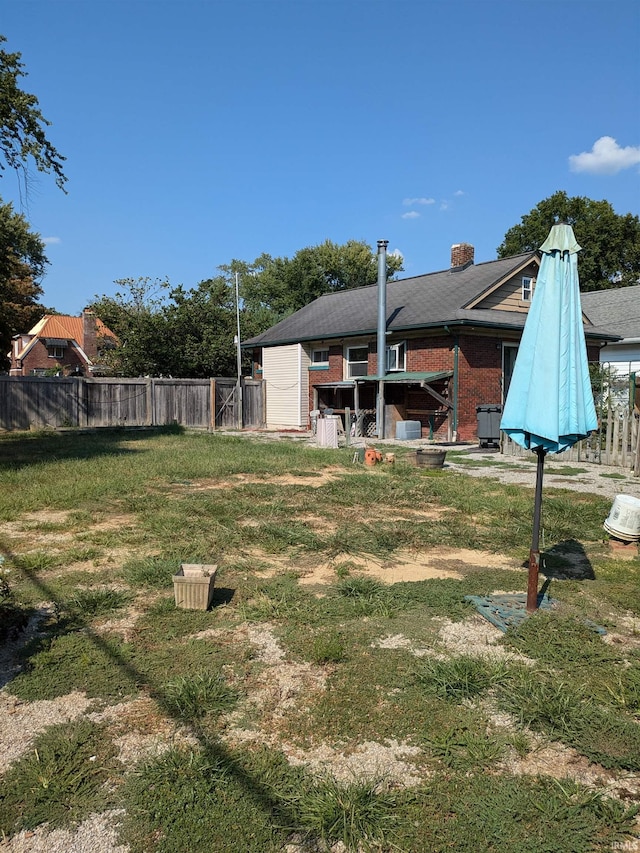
<box><xmin>243</xmin><ymin>243</ymin><xmax>617</xmax><ymax>441</ymax></box>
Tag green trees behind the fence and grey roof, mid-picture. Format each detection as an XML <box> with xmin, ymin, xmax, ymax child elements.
<box><xmin>91</xmin><ymin>240</ymin><xmax>402</xmax><ymax>378</ymax></box>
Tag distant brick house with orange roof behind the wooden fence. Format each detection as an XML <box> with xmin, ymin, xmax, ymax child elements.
<box><xmin>9</xmin><ymin>308</ymin><xmax>116</xmax><ymax>376</ymax></box>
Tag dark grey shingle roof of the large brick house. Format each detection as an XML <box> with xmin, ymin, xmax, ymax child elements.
<box><xmin>243</xmin><ymin>252</ymin><xmax>616</xmax><ymax>347</ymax></box>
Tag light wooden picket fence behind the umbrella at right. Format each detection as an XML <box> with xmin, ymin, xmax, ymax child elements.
<box><xmin>500</xmin><ymin>406</ymin><xmax>640</xmax><ymax>474</ymax></box>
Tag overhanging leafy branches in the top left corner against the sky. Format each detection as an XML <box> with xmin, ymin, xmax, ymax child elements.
<box><xmin>0</xmin><ymin>35</ymin><xmax>67</xmax><ymax>191</ymax></box>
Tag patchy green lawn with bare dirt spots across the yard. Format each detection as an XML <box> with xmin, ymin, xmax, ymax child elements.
<box><xmin>0</xmin><ymin>429</ymin><xmax>640</xmax><ymax>853</ymax></box>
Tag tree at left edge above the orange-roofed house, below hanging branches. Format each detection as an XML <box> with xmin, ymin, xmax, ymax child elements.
<box><xmin>0</xmin><ymin>200</ymin><xmax>47</xmax><ymax>370</ymax></box>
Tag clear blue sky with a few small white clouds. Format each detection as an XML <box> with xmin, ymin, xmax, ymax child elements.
<box><xmin>0</xmin><ymin>0</ymin><xmax>640</xmax><ymax>314</ymax></box>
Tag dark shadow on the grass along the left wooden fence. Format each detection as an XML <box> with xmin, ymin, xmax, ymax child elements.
<box><xmin>0</xmin><ymin>424</ymin><xmax>184</xmax><ymax>471</ymax></box>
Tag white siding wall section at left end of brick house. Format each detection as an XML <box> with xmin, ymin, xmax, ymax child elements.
<box><xmin>262</xmin><ymin>344</ymin><xmax>309</xmax><ymax>429</ymax></box>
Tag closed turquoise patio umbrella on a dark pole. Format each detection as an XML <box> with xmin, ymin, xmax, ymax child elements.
<box><xmin>500</xmin><ymin>223</ymin><xmax>597</xmax><ymax>611</ymax></box>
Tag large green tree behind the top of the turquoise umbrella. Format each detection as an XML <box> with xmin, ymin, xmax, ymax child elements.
<box><xmin>497</xmin><ymin>191</ymin><xmax>640</xmax><ymax>291</ymax></box>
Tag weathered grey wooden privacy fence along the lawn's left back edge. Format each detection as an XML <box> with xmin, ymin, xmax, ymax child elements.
<box><xmin>0</xmin><ymin>376</ymin><xmax>265</xmax><ymax>430</ymax></box>
